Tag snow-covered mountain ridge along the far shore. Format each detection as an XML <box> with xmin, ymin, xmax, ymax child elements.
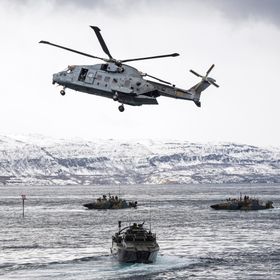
<box><xmin>0</xmin><ymin>136</ymin><xmax>280</xmax><ymax>185</ymax></box>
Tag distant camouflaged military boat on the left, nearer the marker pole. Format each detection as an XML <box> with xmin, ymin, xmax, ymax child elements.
<box><xmin>83</xmin><ymin>194</ymin><xmax>137</xmax><ymax>209</ymax></box>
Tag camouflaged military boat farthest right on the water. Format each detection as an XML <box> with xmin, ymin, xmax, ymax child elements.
<box><xmin>210</xmin><ymin>195</ymin><xmax>274</xmax><ymax>210</ymax></box>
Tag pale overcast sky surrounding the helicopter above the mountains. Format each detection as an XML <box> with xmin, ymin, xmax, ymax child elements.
<box><xmin>0</xmin><ymin>0</ymin><xmax>280</xmax><ymax>146</ymax></box>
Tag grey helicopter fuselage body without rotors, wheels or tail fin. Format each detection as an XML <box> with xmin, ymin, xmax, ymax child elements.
<box><xmin>53</xmin><ymin>63</ymin><xmax>195</xmax><ymax>106</ymax></box>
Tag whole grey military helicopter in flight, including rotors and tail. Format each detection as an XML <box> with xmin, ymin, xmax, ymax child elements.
<box><xmin>39</xmin><ymin>26</ymin><xmax>219</xmax><ymax>112</ymax></box>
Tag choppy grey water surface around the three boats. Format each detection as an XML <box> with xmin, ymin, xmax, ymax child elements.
<box><xmin>0</xmin><ymin>185</ymin><xmax>280</xmax><ymax>279</ymax></box>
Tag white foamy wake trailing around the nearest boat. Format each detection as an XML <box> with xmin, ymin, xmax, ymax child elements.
<box><xmin>0</xmin><ymin>255</ymin><xmax>204</xmax><ymax>279</ymax></box>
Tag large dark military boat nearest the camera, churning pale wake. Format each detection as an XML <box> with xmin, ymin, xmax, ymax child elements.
<box><xmin>111</xmin><ymin>221</ymin><xmax>159</xmax><ymax>263</ymax></box>
